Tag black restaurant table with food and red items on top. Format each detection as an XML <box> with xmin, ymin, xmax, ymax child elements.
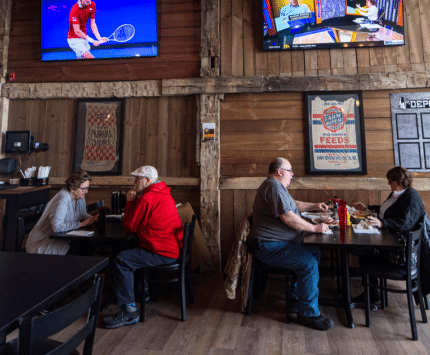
<box><xmin>303</xmin><ymin>227</ymin><xmax>402</xmax><ymax>328</ymax></box>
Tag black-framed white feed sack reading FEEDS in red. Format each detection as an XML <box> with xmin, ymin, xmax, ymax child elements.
<box><xmin>305</xmin><ymin>91</ymin><xmax>367</xmax><ymax>175</ymax></box>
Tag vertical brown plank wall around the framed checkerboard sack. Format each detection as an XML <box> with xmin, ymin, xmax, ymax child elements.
<box><xmin>8</xmin><ymin>96</ymin><xmax>200</xmax><ymax>210</ymax></box>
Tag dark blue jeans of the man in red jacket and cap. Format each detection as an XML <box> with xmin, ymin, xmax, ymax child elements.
<box><xmin>113</xmin><ymin>249</ymin><xmax>177</xmax><ymax>305</ymax></box>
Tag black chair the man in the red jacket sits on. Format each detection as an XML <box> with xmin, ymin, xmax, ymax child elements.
<box><xmin>138</xmin><ymin>215</ymin><xmax>196</xmax><ymax>322</ymax></box>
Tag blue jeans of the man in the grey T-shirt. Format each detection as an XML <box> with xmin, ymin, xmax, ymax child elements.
<box><xmin>255</xmin><ymin>241</ymin><xmax>321</xmax><ymax>317</ymax></box>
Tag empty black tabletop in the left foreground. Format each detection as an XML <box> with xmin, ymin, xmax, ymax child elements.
<box><xmin>0</xmin><ymin>252</ymin><xmax>109</xmax><ymax>350</ymax></box>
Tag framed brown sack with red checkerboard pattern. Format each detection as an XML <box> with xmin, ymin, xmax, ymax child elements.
<box><xmin>73</xmin><ymin>98</ymin><xmax>125</xmax><ymax>175</ymax></box>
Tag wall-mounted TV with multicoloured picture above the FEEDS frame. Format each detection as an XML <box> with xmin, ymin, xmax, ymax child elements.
<box><xmin>263</xmin><ymin>0</ymin><xmax>405</xmax><ymax>51</ymax></box>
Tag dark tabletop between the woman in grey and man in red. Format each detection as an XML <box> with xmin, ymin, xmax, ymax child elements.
<box><xmin>49</xmin><ymin>220</ymin><xmax>133</xmax><ymax>255</ymax></box>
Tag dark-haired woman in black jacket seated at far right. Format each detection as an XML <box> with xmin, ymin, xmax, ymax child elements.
<box><xmin>354</xmin><ymin>166</ymin><xmax>426</xmax><ymax>303</ymax></box>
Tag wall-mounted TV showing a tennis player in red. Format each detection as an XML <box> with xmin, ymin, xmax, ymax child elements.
<box><xmin>41</xmin><ymin>0</ymin><xmax>158</xmax><ymax>61</ymax></box>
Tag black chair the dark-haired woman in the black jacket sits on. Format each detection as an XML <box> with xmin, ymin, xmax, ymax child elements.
<box><xmin>360</xmin><ymin>224</ymin><xmax>427</xmax><ymax>340</ymax></box>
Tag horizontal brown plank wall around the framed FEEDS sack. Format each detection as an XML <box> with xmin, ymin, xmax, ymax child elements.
<box><xmin>220</xmin><ymin>89</ymin><xmax>430</xmax><ymax>262</ymax></box>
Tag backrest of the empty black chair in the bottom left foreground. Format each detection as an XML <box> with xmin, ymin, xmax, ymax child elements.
<box><xmin>19</xmin><ymin>274</ymin><xmax>104</xmax><ymax>355</ymax></box>
